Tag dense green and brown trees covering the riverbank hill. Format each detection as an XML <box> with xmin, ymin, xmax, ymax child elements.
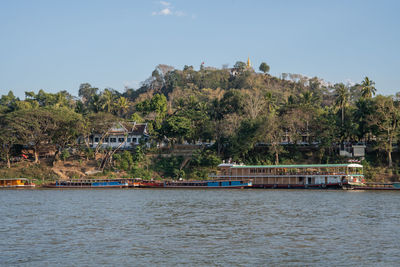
<box><xmin>0</xmin><ymin>62</ymin><xmax>400</xmax><ymax>181</ymax></box>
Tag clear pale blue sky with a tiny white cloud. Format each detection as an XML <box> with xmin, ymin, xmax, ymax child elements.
<box><xmin>0</xmin><ymin>0</ymin><xmax>400</xmax><ymax>97</ymax></box>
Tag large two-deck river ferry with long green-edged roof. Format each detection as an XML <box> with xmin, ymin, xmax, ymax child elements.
<box><xmin>210</xmin><ymin>163</ymin><xmax>365</xmax><ymax>188</ymax></box>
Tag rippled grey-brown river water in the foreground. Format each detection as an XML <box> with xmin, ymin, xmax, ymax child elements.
<box><xmin>0</xmin><ymin>189</ymin><xmax>400</xmax><ymax>266</ymax></box>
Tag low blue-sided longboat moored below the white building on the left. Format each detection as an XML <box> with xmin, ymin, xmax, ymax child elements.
<box><xmin>44</xmin><ymin>179</ymin><xmax>129</xmax><ymax>188</ymax></box>
